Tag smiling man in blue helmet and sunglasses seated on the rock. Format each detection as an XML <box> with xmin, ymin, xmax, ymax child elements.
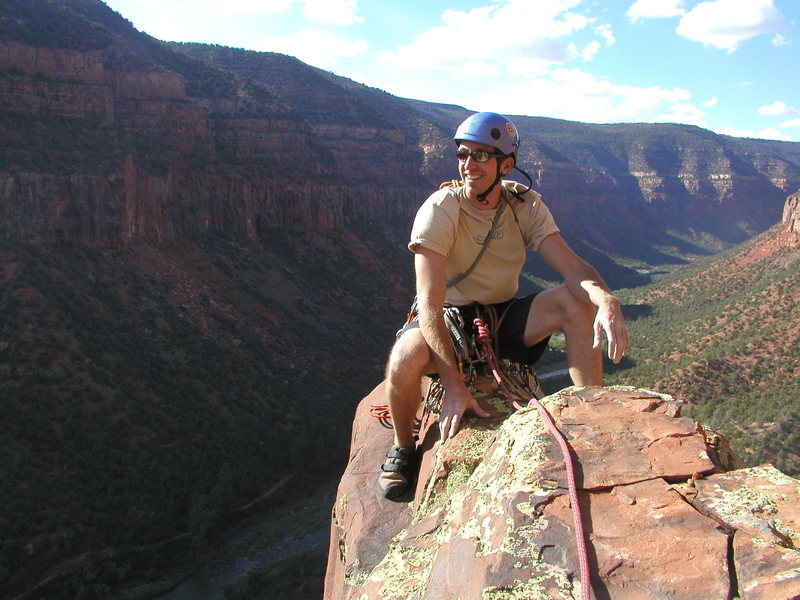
<box><xmin>379</xmin><ymin>113</ymin><xmax>629</xmax><ymax>499</ymax></box>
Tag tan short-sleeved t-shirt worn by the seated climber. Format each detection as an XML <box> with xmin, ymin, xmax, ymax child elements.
<box><xmin>408</xmin><ymin>181</ymin><xmax>559</xmax><ymax>306</ymax></box>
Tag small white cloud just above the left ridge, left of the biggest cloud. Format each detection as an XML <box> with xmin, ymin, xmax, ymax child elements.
<box><xmin>253</xmin><ymin>29</ymin><xmax>367</xmax><ymax>69</ymax></box>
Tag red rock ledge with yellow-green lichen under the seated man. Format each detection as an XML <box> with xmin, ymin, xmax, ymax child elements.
<box><xmin>324</xmin><ymin>382</ymin><xmax>800</xmax><ymax>600</ymax></box>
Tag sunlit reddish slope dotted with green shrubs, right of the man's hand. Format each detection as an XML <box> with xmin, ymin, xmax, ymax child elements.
<box><xmin>608</xmin><ymin>218</ymin><xmax>800</xmax><ymax>476</ymax></box>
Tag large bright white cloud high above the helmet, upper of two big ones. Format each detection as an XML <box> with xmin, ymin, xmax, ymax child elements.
<box><xmin>379</xmin><ymin>0</ymin><xmax>600</xmax><ymax>74</ymax></box>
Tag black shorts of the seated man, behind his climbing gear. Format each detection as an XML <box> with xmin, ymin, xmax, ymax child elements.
<box><xmin>397</xmin><ymin>294</ymin><xmax>550</xmax><ymax>365</ymax></box>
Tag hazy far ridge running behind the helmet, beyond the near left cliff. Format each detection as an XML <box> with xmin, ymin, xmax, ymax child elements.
<box><xmin>171</xmin><ymin>44</ymin><xmax>800</xmax><ymax>268</ymax></box>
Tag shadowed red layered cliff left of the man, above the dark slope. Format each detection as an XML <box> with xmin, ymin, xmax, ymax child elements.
<box><xmin>0</xmin><ymin>0</ymin><xmax>427</xmax><ymax>245</ymax></box>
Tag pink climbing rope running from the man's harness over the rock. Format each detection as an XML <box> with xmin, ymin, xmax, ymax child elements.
<box><xmin>473</xmin><ymin>317</ymin><xmax>592</xmax><ymax>600</ymax></box>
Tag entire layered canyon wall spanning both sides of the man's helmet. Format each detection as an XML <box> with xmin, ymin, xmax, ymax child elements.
<box><xmin>0</xmin><ymin>0</ymin><xmax>800</xmax><ymax>260</ymax></box>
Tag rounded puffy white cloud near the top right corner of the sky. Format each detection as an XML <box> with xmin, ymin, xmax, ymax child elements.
<box><xmin>677</xmin><ymin>0</ymin><xmax>785</xmax><ymax>52</ymax></box>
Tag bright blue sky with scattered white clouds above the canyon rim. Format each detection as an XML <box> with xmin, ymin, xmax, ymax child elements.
<box><xmin>105</xmin><ymin>0</ymin><xmax>800</xmax><ymax>141</ymax></box>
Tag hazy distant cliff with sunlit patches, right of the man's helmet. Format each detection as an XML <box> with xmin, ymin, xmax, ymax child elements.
<box><xmin>400</xmin><ymin>100</ymin><xmax>800</xmax><ymax>255</ymax></box>
